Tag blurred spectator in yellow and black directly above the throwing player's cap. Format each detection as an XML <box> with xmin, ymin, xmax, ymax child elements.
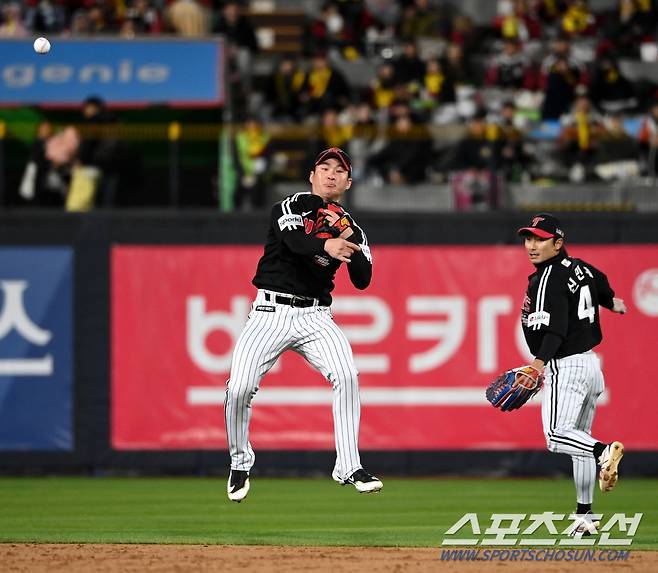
<box><xmin>300</xmin><ymin>53</ymin><xmax>350</xmax><ymax>115</ymax></box>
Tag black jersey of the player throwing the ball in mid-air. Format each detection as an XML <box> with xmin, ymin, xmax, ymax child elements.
<box><xmin>252</xmin><ymin>192</ymin><xmax>372</xmax><ymax>306</ymax></box>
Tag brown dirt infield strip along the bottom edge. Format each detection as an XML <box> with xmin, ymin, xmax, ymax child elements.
<box><xmin>0</xmin><ymin>543</ymin><xmax>658</xmax><ymax>573</ymax></box>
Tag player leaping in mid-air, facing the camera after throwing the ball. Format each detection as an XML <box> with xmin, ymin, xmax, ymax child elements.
<box><xmin>224</xmin><ymin>147</ymin><xmax>382</xmax><ymax>502</ymax></box>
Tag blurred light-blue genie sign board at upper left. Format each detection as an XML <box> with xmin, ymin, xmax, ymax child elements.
<box><xmin>0</xmin><ymin>38</ymin><xmax>224</xmax><ymax>106</ymax></box>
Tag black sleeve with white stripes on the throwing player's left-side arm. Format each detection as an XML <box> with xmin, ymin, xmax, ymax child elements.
<box><xmin>271</xmin><ymin>195</ymin><xmax>327</xmax><ymax>255</ymax></box>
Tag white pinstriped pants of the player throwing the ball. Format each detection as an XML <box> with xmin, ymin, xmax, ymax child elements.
<box><xmin>224</xmin><ymin>289</ymin><xmax>361</xmax><ymax>480</ymax></box>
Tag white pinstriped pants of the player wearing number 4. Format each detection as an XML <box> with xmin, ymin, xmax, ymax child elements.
<box><xmin>542</xmin><ymin>350</ymin><xmax>604</xmax><ymax>503</ymax></box>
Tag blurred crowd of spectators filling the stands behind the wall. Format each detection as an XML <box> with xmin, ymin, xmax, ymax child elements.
<box><xmin>0</xmin><ymin>0</ymin><xmax>658</xmax><ymax>207</ymax></box>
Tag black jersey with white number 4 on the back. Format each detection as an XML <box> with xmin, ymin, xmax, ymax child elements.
<box><xmin>521</xmin><ymin>254</ymin><xmax>615</xmax><ymax>358</ymax></box>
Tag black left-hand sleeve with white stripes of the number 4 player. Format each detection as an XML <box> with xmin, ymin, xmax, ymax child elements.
<box><xmin>528</xmin><ymin>265</ymin><xmax>569</xmax><ymax>338</ymax></box>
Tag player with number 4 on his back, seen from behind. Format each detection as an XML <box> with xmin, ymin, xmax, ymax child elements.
<box><xmin>518</xmin><ymin>213</ymin><xmax>626</xmax><ymax>535</ymax></box>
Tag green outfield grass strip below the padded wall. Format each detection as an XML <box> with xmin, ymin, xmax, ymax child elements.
<box><xmin>0</xmin><ymin>477</ymin><xmax>658</xmax><ymax>549</ymax></box>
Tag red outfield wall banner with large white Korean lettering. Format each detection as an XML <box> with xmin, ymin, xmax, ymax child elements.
<box><xmin>112</xmin><ymin>245</ymin><xmax>658</xmax><ymax>450</ymax></box>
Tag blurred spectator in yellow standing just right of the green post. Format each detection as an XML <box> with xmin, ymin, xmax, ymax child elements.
<box><xmin>234</xmin><ymin>116</ymin><xmax>271</xmax><ymax>210</ymax></box>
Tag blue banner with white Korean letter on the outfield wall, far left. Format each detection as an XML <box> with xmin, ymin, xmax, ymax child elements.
<box><xmin>0</xmin><ymin>247</ymin><xmax>74</xmax><ymax>451</ymax></box>
